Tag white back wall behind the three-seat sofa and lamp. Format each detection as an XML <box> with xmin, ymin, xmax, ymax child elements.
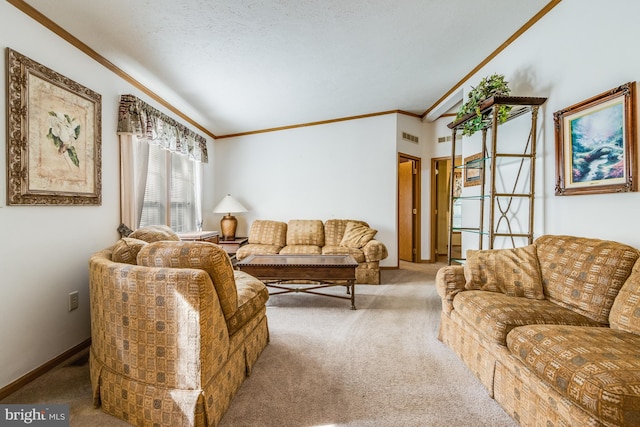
<box><xmin>210</xmin><ymin>114</ymin><xmax>398</xmax><ymax>266</ymax></box>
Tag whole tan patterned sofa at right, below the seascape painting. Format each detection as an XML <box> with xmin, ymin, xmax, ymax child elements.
<box><xmin>436</xmin><ymin>235</ymin><xmax>640</xmax><ymax>426</ymax></box>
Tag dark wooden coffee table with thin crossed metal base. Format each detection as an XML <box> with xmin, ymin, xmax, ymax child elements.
<box><xmin>237</xmin><ymin>255</ymin><xmax>358</xmax><ymax>310</ymax></box>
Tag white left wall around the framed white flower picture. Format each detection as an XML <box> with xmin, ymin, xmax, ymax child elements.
<box><xmin>0</xmin><ymin>1</ymin><xmax>211</xmax><ymax>387</ymax></box>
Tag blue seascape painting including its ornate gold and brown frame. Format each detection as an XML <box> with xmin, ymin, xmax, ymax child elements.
<box><xmin>553</xmin><ymin>82</ymin><xmax>638</xmax><ymax>196</ymax></box>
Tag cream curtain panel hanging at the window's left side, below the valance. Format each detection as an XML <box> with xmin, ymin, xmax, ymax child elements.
<box><xmin>119</xmin><ymin>133</ymin><xmax>149</xmax><ymax>230</ymax></box>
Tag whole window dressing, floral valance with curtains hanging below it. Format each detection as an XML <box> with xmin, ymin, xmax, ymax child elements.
<box><xmin>118</xmin><ymin>95</ymin><xmax>208</xmax><ymax>231</ymax></box>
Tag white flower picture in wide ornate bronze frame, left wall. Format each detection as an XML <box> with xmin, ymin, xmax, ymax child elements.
<box><xmin>7</xmin><ymin>48</ymin><xmax>102</xmax><ymax>205</ymax></box>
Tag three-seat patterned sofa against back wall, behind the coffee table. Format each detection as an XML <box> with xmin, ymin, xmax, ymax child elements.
<box><xmin>236</xmin><ymin>219</ymin><xmax>388</xmax><ymax>285</ymax></box>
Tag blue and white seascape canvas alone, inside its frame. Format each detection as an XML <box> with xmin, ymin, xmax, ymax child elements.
<box><xmin>569</xmin><ymin>100</ymin><xmax>625</xmax><ymax>184</ymax></box>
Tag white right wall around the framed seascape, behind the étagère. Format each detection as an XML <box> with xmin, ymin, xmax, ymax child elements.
<box><xmin>448</xmin><ymin>0</ymin><xmax>640</xmax><ymax>247</ymax></box>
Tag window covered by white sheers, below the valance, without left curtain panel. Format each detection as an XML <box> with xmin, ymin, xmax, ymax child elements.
<box><xmin>140</xmin><ymin>145</ymin><xmax>202</xmax><ymax>232</ymax></box>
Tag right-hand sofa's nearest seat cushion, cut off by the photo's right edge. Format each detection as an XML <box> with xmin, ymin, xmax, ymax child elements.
<box><xmin>507</xmin><ymin>325</ymin><xmax>640</xmax><ymax>426</ymax></box>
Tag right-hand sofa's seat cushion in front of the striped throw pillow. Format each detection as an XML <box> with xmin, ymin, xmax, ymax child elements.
<box><xmin>453</xmin><ymin>291</ymin><xmax>600</xmax><ymax>345</ymax></box>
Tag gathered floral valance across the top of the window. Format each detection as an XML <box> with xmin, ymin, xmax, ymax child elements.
<box><xmin>118</xmin><ymin>95</ymin><xmax>209</xmax><ymax>163</ymax></box>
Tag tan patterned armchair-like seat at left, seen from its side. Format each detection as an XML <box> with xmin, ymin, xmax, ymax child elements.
<box><xmin>89</xmin><ymin>226</ymin><xmax>269</xmax><ymax>426</ymax></box>
